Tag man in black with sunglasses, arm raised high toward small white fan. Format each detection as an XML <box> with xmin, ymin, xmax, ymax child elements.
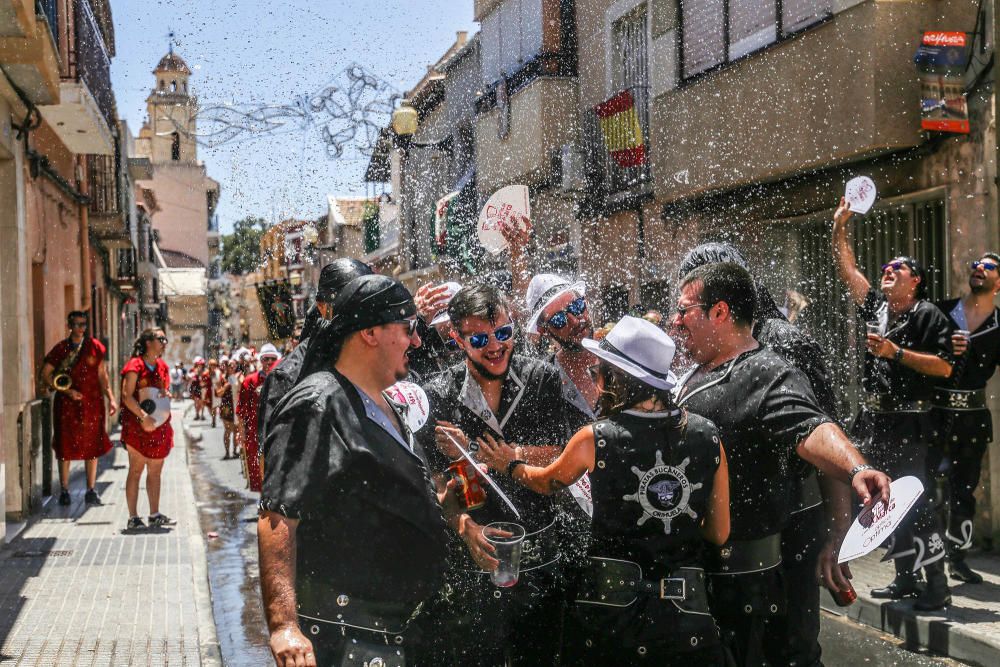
<box><xmin>833</xmin><ymin>199</ymin><xmax>952</xmax><ymax>611</ymax></box>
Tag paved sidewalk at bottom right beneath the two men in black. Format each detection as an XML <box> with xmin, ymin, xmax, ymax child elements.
<box><xmin>821</xmin><ymin>549</ymin><xmax>1000</xmax><ymax>666</ymax></box>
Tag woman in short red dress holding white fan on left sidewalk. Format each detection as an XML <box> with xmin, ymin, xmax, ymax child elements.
<box><xmin>122</xmin><ymin>329</ymin><xmax>177</xmax><ymax>530</ymax></box>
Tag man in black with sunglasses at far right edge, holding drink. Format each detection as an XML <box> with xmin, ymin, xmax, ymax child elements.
<box><xmin>931</xmin><ymin>252</ymin><xmax>1000</xmax><ymax>584</ymax></box>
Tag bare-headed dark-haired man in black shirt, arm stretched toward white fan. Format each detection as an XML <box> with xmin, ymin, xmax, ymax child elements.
<box><xmin>671</xmin><ymin>263</ymin><xmax>889</xmax><ymax>666</ymax></box>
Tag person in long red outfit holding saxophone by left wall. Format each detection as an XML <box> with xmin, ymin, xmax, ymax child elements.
<box><xmin>41</xmin><ymin>310</ymin><xmax>118</xmax><ymax>505</ymax></box>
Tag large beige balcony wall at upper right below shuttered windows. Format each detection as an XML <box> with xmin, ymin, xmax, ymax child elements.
<box><xmin>650</xmin><ymin>0</ymin><xmax>975</xmax><ymax>202</ymax></box>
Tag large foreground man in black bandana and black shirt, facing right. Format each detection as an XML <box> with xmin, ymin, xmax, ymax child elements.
<box><xmin>257</xmin><ymin>276</ymin><xmax>448</xmax><ymax>667</ymax></box>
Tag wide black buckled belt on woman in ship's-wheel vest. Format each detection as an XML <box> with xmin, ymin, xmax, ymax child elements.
<box><xmin>576</xmin><ymin>556</ymin><xmax>709</xmax><ymax>614</ymax></box>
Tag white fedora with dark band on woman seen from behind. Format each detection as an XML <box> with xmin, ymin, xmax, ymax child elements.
<box><xmin>583</xmin><ymin>316</ymin><xmax>677</xmax><ymax>389</ymax></box>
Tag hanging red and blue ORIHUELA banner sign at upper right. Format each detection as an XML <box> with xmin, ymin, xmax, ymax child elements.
<box><xmin>913</xmin><ymin>30</ymin><xmax>970</xmax><ymax>134</ymax></box>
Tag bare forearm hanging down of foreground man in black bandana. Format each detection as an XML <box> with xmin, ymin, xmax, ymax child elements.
<box><xmin>257</xmin><ymin>512</ymin><xmax>316</xmax><ymax>667</ymax></box>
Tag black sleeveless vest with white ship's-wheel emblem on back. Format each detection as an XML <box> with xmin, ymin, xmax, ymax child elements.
<box><xmin>590</xmin><ymin>411</ymin><xmax>719</xmax><ymax>577</ymax></box>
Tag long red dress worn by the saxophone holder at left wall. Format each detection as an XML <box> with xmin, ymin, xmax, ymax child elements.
<box><xmin>45</xmin><ymin>337</ymin><xmax>111</xmax><ymax>461</ymax></box>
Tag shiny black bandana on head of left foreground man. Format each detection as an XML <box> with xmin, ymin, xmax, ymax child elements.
<box><xmin>331</xmin><ymin>274</ymin><xmax>417</xmax><ymax>336</ymax></box>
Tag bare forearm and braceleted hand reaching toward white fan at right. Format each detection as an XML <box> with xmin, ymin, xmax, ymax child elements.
<box><xmin>796</xmin><ymin>422</ymin><xmax>889</xmax><ymax>505</ymax></box>
